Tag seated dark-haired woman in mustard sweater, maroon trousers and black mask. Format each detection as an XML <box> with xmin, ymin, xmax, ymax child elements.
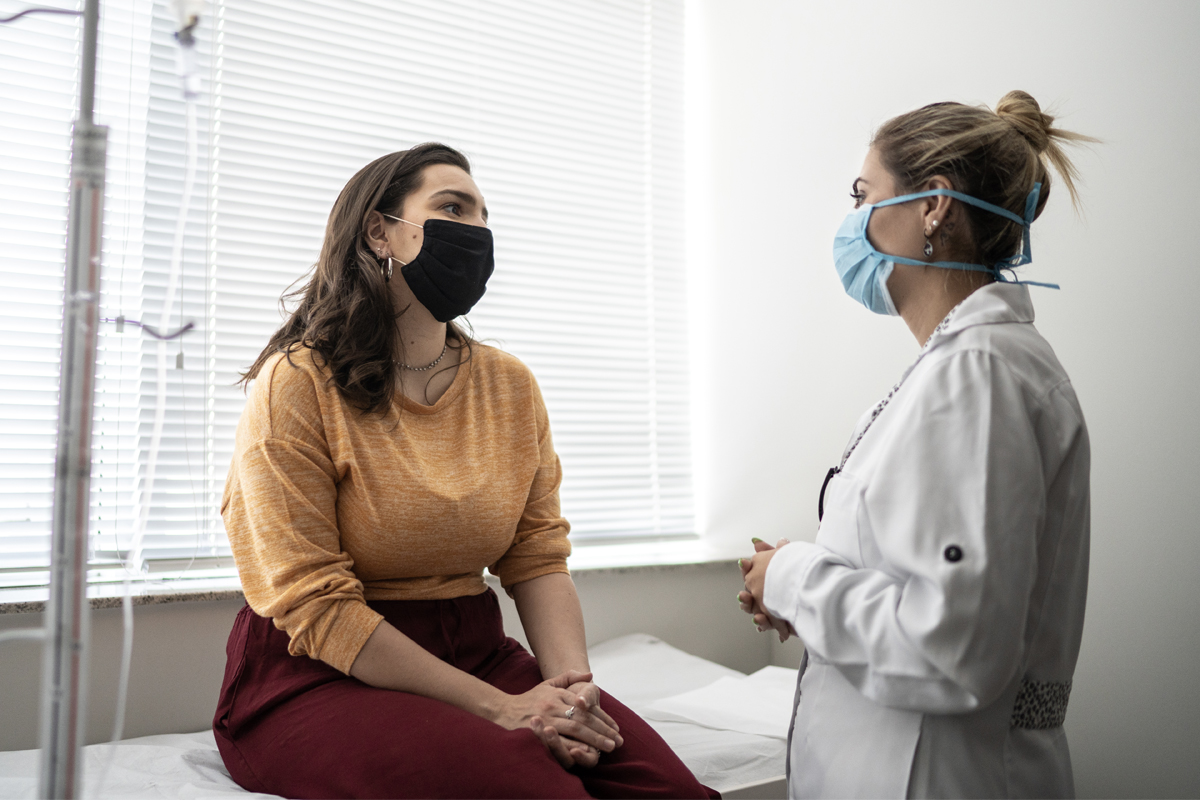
<box><xmin>214</xmin><ymin>144</ymin><xmax>713</xmax><ymax>798</ymax></box>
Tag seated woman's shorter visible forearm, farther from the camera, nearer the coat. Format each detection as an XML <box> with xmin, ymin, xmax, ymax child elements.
<box><xmin>512</xmin><ymin>572</ymin><xmax>590</xmax><ymax>679</ymax></box>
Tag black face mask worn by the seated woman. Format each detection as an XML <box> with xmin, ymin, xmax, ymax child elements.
<box><xmin>385</xmin><ymin>215</ymin><xmax>496</xmax><ymax>323</ymax></box>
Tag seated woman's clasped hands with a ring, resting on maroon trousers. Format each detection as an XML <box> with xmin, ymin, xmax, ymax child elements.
<box><xmin>498</xmin><ymin>669</ymin><xmax>624</xmax><ymax>769</ymax></box>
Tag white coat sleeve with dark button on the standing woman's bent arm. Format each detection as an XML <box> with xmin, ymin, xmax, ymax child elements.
<box><xmin>764</xmin><ymin>350</ymin><xmax>1045</xmax><ymax>714</ymax></box>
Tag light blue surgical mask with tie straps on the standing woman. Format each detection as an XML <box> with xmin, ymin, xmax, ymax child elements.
<box><xmin>833</xmin><ymin>184</ymin><xmax>1058</xmax><ymax>315</ymax></box>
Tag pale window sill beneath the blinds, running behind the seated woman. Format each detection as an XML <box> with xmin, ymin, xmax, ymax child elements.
<box><xmin>0</xmin><ymin>537</ymin><xmax>745</xmax><ymax>615</ymax></box>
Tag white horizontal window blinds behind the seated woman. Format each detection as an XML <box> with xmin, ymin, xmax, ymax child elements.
<box><xmin>0</xmin><ymin>0</ymin><xmax>694</xmax><ymax>594</ymax></box>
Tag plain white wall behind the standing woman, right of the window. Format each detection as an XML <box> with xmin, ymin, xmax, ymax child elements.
<box><xmin>696</xmin><ymin>0</ymin><xmax>1200</xmax><ymax>796</ymax></box>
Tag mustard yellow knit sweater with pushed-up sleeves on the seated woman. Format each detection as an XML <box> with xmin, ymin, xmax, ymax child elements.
<box><xmin>221</xmin><ymin>344</ymin><xmax>571</xmax><ymax>673</ymax></box>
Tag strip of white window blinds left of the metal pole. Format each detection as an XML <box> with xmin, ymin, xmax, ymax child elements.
<box><xmin>0</xmin><ymin>7</ymin><xmax>79</xmax><ymax>581</ymax></box>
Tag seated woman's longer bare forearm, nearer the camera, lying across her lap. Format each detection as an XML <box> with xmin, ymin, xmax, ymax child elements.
<box><xmin>350</xmin><ymin>622</ymin><xmax>509</xmax><ymax>722</ymax></box>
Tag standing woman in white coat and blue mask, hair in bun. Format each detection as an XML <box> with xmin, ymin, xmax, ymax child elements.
<box><xmin>739</xmin><ymin>91</ymin><xmax>1090</xmax><ymax>798</ymax></box>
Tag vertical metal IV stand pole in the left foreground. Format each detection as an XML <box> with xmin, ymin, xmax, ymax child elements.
<box><xmin>38</xmin><ymin>0</ymin><xmax>108</xmax><ymax>799</ymax></box>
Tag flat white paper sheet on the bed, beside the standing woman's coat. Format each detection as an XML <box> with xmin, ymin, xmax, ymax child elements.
<box><xmin>643</xmin><ymin>667</ymin><xmax>798</xmax><ymax>739</ymax></box>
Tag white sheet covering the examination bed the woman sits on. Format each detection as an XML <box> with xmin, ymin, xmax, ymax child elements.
<box><xmin>0</xmin><ymin>633</ymin><xmax>792</xmax><ymax>800</ymax></box>
